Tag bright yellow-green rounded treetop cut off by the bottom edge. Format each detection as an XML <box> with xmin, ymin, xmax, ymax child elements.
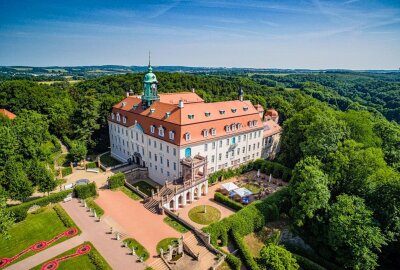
<box><xmin>257</xmin><ymin>244</ymin><xmax>299</xmax><ymax>270</ymax></box>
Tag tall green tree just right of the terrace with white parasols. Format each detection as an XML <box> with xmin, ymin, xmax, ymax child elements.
<box><xmin>290</xmin><ymin>157</ymin><xmax>330</xmax><ymax>227</ymax></box>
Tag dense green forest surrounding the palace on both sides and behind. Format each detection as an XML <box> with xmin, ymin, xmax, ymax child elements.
<box><xmin>0</xmin><ymin>70</ymin><xmax>400</xmax><ymax>269</ymax></box>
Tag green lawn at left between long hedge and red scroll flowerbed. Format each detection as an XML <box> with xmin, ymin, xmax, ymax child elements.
<box><xmin>0</xmin><ymin>206</ymin><xmax>77</xmax><ymax>263</ymax></box>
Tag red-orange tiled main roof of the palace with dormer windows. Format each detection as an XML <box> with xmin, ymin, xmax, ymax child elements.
<box><xmin>109</xmin><ymin>93</ymin><xmax>262</xmax><ymax>145</ymax></box>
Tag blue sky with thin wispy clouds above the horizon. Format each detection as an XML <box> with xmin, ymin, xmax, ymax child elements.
<box><xmin>0</xmin><ymin>0</ymin><xmax>400</xmax><ymax>69</ymax></box>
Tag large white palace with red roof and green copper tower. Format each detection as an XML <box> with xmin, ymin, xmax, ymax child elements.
<box><xmin>108</xmin><ymin>64</ymin><xmax>281</xmax><ymax>211</ymax></box>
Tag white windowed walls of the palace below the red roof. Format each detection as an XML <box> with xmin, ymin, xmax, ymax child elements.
<box><xmin>108</xmin><ymin>120</ymin><xmax>263</xmax><ymax>185</ymax></box>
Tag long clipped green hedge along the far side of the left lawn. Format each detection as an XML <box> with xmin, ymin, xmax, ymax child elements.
<box><xmin>7</xmin><ymin>190</ymin><xmax>72</xmax><ymax>222</ymax></box>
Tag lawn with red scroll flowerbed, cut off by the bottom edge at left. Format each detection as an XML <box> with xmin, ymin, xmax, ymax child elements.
<box><xmin>32</xmin><ymin>242</ymin><xmax>112</xmax><ymax>270</ymax></box>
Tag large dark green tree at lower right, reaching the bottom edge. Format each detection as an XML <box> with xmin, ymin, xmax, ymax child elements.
<box><xmin>327</xmin><ymin>195</ymin><xmax>385</xmax><ymax>269</ymax></box>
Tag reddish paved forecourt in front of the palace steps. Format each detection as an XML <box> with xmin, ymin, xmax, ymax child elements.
<box><xmin>96</xmin><ymin>190</ymin><xmax>181</xmax><ymax>263</ymax></box>
